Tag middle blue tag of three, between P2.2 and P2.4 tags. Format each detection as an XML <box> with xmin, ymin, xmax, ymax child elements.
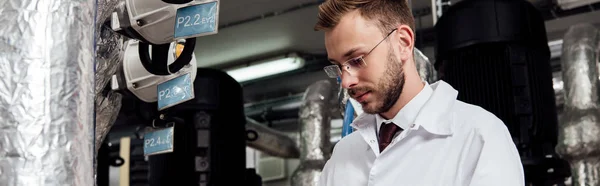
<box><xmin>157</xmin><ymin>73</ymin><xmax>195</xmax><ymax>111</ymax></box>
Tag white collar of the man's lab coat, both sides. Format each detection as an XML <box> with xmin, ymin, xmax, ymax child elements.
<box><xmin>352</xmin><ymin>80</ymin><xmax>458</xmax><ymax>135</ymax></box>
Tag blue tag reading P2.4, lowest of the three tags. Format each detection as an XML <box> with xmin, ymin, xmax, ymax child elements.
<box><xmin>144</xmin><ymin>127</ymin><xmax>175</xmax><ymax>156</ymax></box>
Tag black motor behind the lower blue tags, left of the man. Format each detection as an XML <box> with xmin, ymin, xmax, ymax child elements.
<box><xmin>148</xmin><ymin>68</ymin><xmax>247</xmax><ymax>186</ymax></box>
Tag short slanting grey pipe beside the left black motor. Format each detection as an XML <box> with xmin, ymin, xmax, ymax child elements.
<box><xmin>246</xmin><ymin>118</ymin><xmax>300</xmax><ymax>158</ymax></box>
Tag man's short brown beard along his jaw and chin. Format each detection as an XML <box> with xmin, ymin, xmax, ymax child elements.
<box><xmin>350</xmin><ymin>48</ymin><xmax>404</xmax><ymax>114</ymax></box>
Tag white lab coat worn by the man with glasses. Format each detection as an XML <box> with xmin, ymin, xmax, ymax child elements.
<box><xmin>319</xmin><ymin>81</ymin><xmax>525</xmax><ymax>186</ymax></box>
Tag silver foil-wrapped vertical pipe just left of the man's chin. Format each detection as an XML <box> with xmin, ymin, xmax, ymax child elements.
<box><xmin>291</xmin><ymin>80</ymin><xmax>337</xmax><ymax>186</ymax></box>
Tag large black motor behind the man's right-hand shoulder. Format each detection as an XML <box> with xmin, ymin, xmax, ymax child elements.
<box><xmin>435</xmin><ymin>0</ymin><xmax>570</xmax><ymax>186</ymax></box>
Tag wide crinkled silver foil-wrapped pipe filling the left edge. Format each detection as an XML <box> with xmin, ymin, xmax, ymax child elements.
<box><xmin>0</xmin><ymin>0</ymin><xmax>96</xmax><ymax>186</ymax></box>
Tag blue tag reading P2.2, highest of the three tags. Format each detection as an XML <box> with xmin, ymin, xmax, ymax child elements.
<box><xmin>173</xmin><ymin>1</ymin><xmax>219</xmax><ymax>39</ymax></box>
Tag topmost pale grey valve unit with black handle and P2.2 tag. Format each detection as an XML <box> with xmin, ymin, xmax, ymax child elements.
<box><xmin>110</xmin><ymin>0</ymin><xmax>219</xmax><ymax>75</ymax></box>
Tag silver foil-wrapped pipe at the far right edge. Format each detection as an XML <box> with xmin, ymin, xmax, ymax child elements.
<box><xmin>556</xmin><ymin>24</ymin><xmax>600</xmax><ymax>186</ymax></box>
